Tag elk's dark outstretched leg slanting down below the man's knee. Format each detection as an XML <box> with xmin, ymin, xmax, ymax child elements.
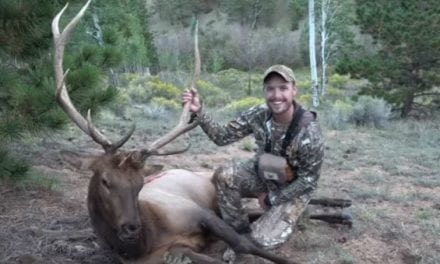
<box><xmin>199</xmin><ymin>213</ymin><xmax>295</xmax><ymax>264</ymax></box>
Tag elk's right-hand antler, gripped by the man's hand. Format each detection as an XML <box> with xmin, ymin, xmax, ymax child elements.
<box><xmin>142</xmin><ymin>19</ymin><xmax>201</xmax><ymax>156</ymax></box>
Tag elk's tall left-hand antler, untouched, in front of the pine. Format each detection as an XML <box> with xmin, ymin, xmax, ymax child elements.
<box><xmin>52</xmin><ymin>0</ymin><xmax>135</xmax><ymax>153</ymax></box>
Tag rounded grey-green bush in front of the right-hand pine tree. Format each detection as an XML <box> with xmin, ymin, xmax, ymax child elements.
<box><xmin>351</xmin><ymin>95</ymin><xmax>391</xmax><ymax>128</ymax></box>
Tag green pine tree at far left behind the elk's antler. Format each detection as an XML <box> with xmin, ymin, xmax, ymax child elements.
<box><xmin>0</xmin><ymin>0</ymin><xmax>121</xmax><ymax>180</ymax></box>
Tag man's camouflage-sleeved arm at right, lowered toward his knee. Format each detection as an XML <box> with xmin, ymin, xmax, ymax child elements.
<box><xmin>271</xmin><ymin>122</ymin><xmax>324</xmax><ymax>205</ymax></box>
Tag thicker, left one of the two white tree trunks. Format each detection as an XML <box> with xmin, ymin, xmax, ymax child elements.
<box><xmin>309</xmin><ymin>0</ymin><xmax>319</xmax><ymax>107</ymax></box>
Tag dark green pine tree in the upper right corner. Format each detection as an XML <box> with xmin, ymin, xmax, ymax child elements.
<box><xmin>337</xmin><ymin>0</ymin><xmax>440</xmax><ymax>117</ymax></box>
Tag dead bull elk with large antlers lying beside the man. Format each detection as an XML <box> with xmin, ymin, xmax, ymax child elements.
<box><xmin>52</xmin><ymin>0</ymin><xmax>293</xmax><ymax>264</ymax></box>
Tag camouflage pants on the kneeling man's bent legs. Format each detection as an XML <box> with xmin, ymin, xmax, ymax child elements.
<box><xmin>214</xmin><ymin>159</ymin><xmax>310</xmax><ymax>248</ymax></box>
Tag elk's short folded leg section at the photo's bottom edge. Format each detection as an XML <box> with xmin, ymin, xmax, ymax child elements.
<box><xmin>165</xmin><ymin>246</ymin><xmax>225</xmax><ymax>264</ymax></box>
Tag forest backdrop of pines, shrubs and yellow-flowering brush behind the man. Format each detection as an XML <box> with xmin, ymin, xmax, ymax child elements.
<box><xmin>0</xmin><ymin>0</ymin><xmax>440</xmax><ymax>196</ymax></box>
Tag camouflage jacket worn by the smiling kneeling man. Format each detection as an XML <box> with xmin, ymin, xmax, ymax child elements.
<box><xmin>197</xmin><ymin>105</ymin><xmax>324</xmax><ymax>205</ymax></box>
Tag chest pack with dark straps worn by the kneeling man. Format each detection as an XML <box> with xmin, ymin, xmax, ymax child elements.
<box><xmin>258</xmin><ymin>106</ymin><xmax>305</xmax><ymax>186</ymax></box>
